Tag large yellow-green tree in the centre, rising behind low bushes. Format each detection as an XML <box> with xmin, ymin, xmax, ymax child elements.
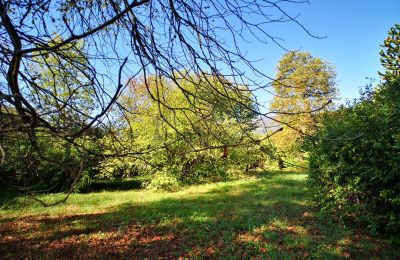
<box><xmin>100</xmin><ymin>75</ymin><xmax>257</xmax><ymax>181</ymax></box>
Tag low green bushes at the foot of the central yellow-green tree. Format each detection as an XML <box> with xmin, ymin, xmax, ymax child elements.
<box><xmin>141</xmin><ymin>145</ymin><xmax>267</xmax><ymax>191</ymax></box>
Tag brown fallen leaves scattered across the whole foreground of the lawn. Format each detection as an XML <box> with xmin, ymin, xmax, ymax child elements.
<box><xmin>0</xmin><ymin>208</ymin><xmax>394</xmax><ymax>259</ymax></box>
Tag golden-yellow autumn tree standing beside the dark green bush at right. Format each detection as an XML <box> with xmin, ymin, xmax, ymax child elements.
<box><xmin>270</xmin><ymin>51</ymin><xmax>337</xmax><ymax>152</ymax></box>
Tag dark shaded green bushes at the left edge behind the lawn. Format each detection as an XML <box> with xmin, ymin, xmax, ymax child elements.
<box><xmin>0</xmin><ymin>133</ymin><xmax>100</xmax><ymax>192</ymax></box>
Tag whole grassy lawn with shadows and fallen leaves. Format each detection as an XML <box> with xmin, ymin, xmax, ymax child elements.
<box><xmin>0</xmin><ymin>172</ymin><xmax>400</xmax><ymax>259</ymax></box>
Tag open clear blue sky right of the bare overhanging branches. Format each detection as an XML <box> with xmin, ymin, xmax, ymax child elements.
<box><xmin>244</xmin><ymin>0</ymin><xmax>400</xmax><ymax>103</ymax></box>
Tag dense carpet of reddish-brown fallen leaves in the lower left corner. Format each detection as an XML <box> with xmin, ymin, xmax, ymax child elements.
<box><xmin>0</xmin><ymin>214</ymin><xmax>182</xmax><ymax>259</ymax></box>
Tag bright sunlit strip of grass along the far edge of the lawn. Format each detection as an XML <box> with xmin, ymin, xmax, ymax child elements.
<box><xmin>0</xmin><ymin>173</ymin><xmax>308</xmax><ymax>220</ymax></box>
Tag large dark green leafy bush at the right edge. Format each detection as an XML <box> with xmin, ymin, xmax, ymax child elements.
<box><xmin>307</xmin><ymin>27</ymin><xmax>400</xmax><ymax>239</ymax></box>
